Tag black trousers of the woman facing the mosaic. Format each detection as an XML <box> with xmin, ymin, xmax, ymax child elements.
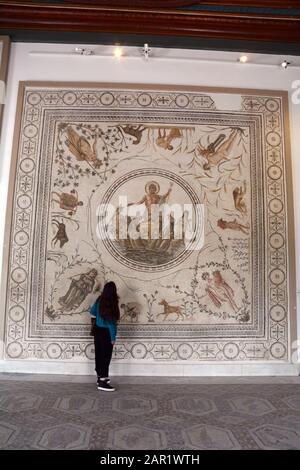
<box><xmin>94</xmin><ymin>326</ymin><xmax>113</xmax><ymax>377</ymax></box>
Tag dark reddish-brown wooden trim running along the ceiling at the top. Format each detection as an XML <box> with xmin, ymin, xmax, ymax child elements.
<box><xmin>0</xmin><ymin>1</ymin><xmax>300</xmax><ymax>44</ymax></box>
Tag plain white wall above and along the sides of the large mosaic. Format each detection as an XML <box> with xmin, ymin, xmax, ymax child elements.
<box><xmin>0</xmin><ymin>43</ymin><xmax>300</xmax><ymax>370</ymax></box>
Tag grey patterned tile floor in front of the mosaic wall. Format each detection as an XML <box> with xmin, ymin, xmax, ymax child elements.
<box><xmin>0</xmin><ymin>374</ymin><xmax>300</xmax><ymax>450</ymax></box>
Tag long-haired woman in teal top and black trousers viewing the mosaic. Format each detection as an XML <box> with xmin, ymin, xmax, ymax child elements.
<box><xmin>90</xmin><ymin>282</ymin><xmax>120</xmax><ymax>392</ymax></box>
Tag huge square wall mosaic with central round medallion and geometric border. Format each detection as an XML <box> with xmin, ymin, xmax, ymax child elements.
<box><xmin>4</xmin><ymin>83</ymin><xmax>295</xmax><ymax>364</ymax></box>
